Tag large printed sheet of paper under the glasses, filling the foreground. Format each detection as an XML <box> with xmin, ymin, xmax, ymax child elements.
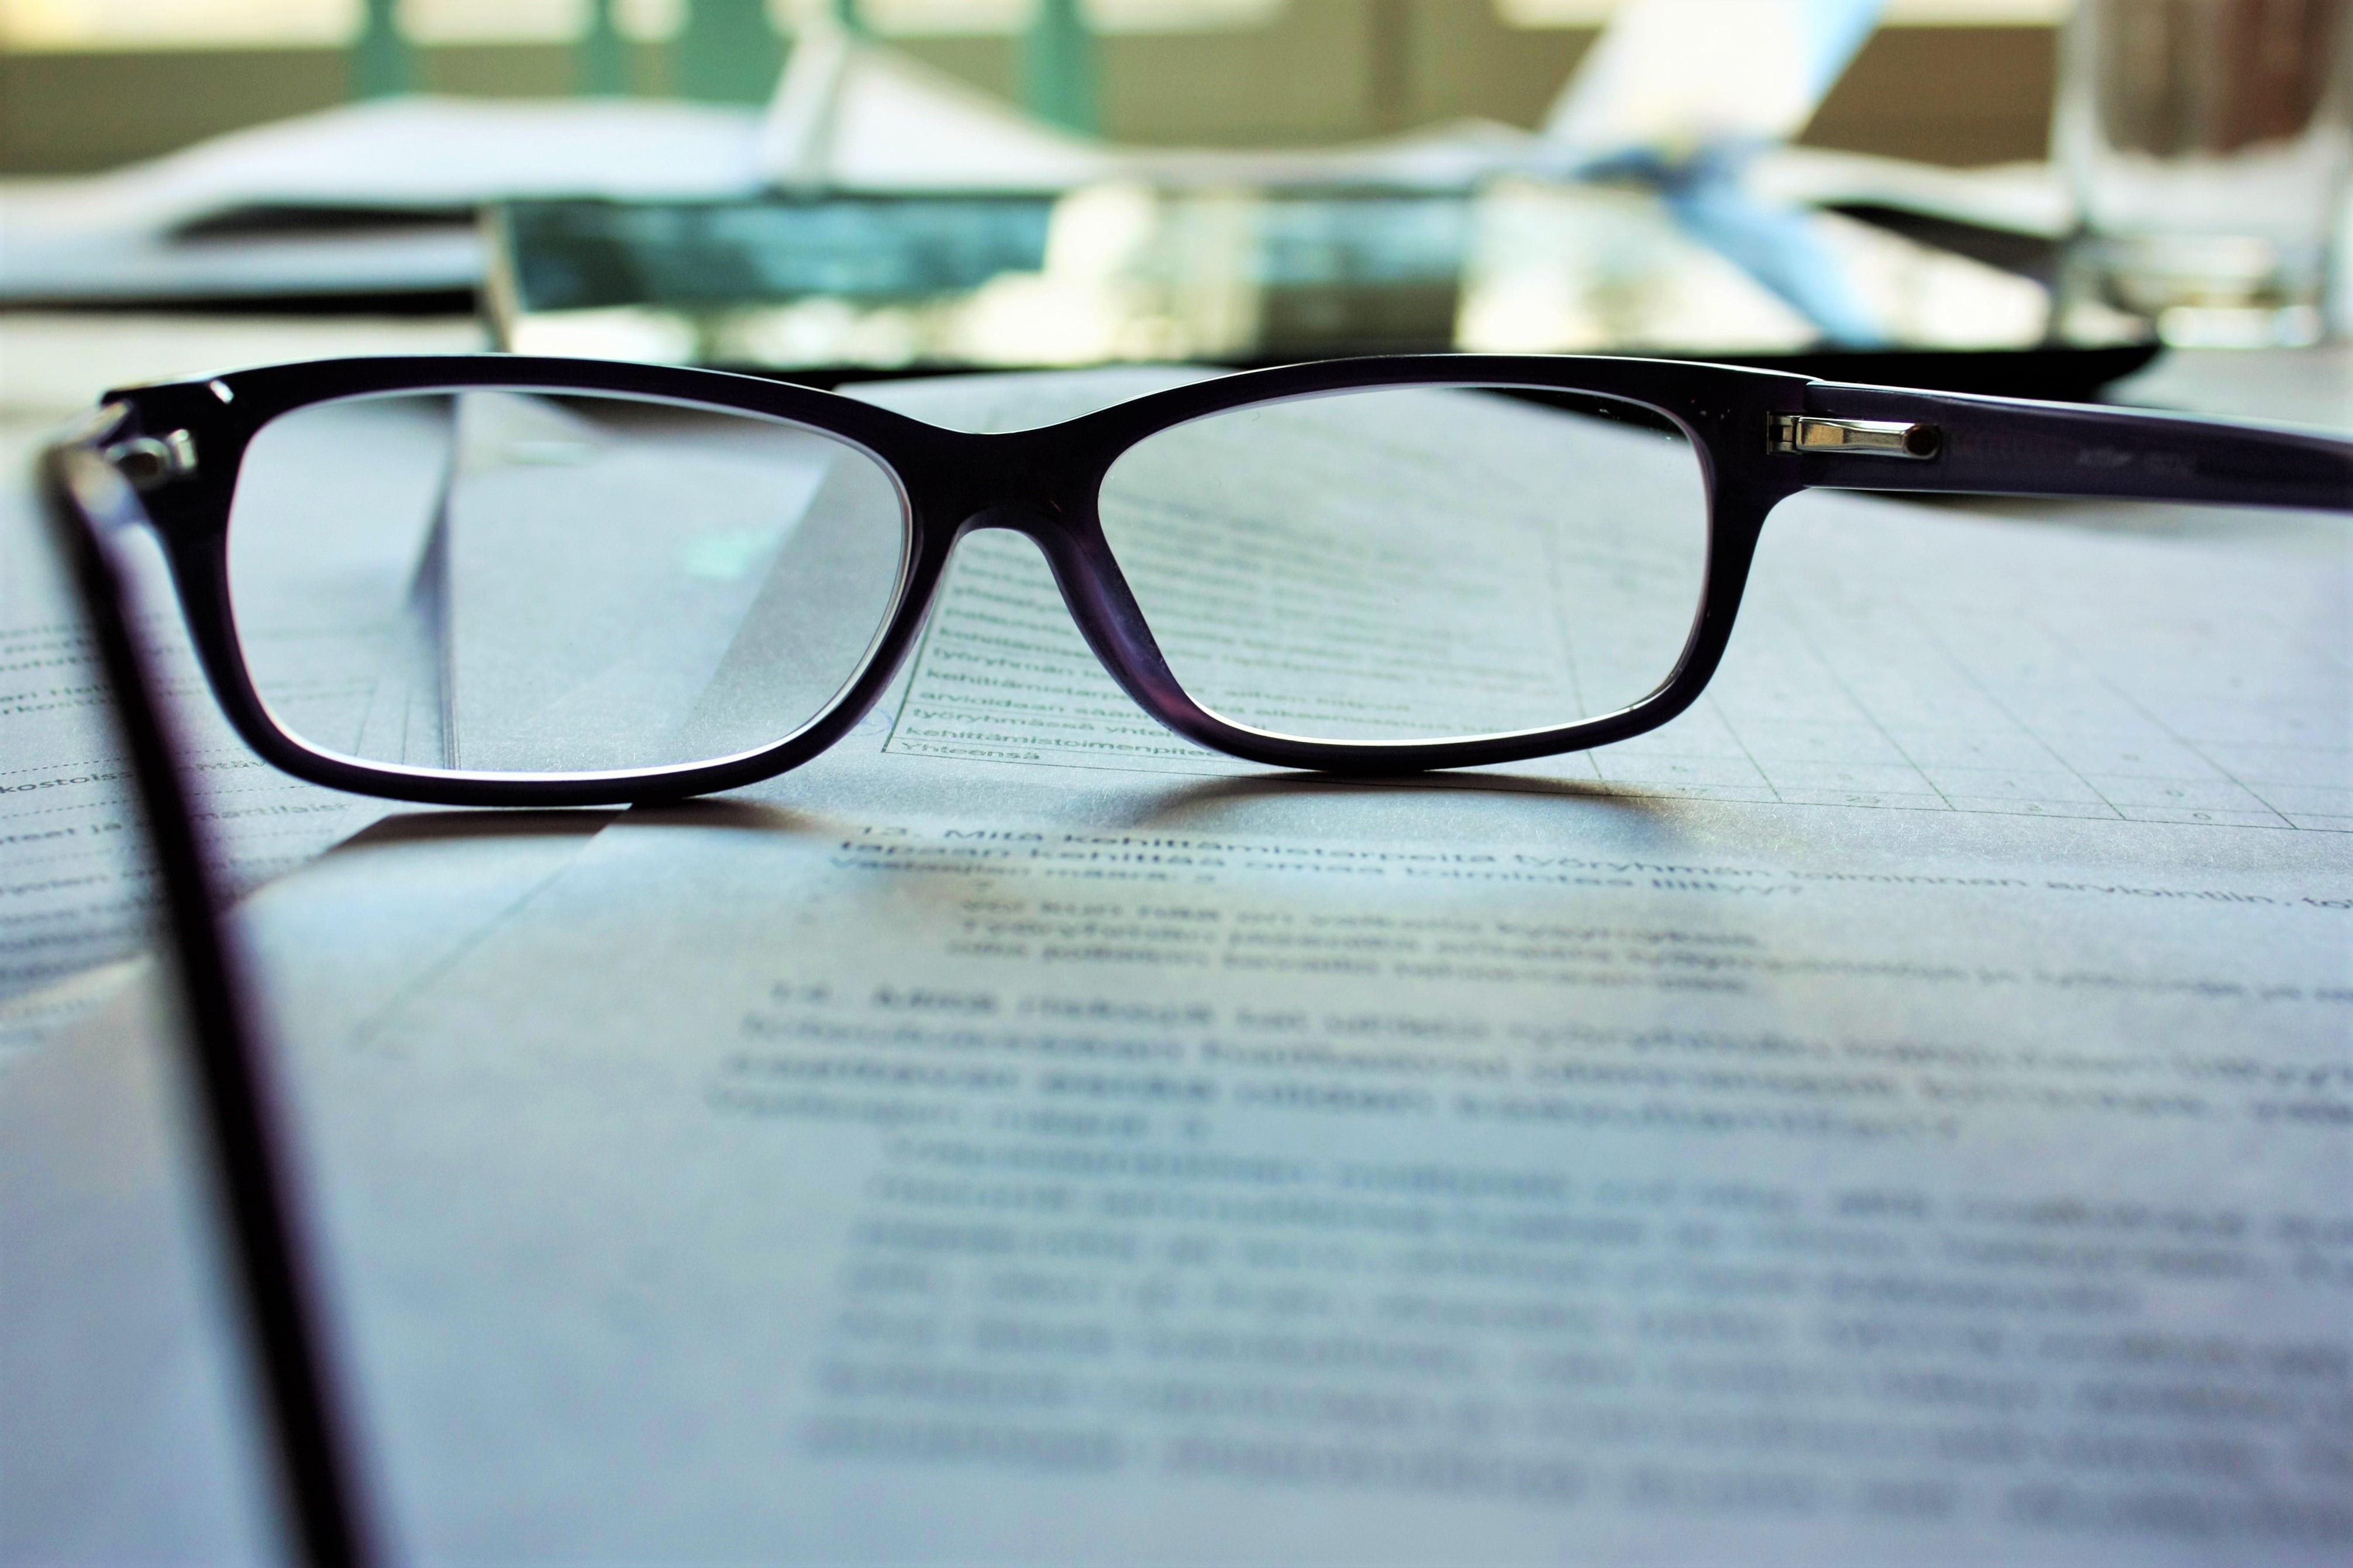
<box><xmin>0</xmin><ymin>362</ymin><xmax>2353</xmax><ymax>1563</ymax></box>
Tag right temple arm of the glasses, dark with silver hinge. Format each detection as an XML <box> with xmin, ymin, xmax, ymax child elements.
<box><xmin>1767</xmin><ymin>381</ymin><xmax>2353</xmax><ymax>511</ymax></box>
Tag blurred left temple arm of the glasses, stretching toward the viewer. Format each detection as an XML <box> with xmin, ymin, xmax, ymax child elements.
<box><xmin>37</xmin><ymin>423</ymin><xmax>384</xmax><ymax>1566</ymax></box>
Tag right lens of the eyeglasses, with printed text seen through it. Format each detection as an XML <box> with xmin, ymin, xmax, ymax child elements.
<box><xmin>1101</xmin><ymin>388</ymin><xmax>1708</xmax><ymax>742</ymax></box>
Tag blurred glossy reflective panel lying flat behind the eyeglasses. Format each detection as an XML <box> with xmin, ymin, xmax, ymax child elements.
<box><xmin>490</xmin><ymin>179</ymin><xmax>2049</xmax><ymax>372</ymax></box>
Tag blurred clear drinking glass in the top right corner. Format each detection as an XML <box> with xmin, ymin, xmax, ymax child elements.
<box><xmin>2054</xmin><ymin>0</ymin><xmax>2353</xmax><ymax>346</ymax></box>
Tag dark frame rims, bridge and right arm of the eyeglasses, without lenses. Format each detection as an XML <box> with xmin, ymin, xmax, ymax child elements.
<box><xmin>55</xmin><ymin>353</ymin><xmax>2353</xmax><ymax>805</ymax></box>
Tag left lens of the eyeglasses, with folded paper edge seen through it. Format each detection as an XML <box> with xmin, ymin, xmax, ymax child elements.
<box><xmin>228</xmin><ymin>391</ymin><xmax>906</xmax><ymax>772</ymax></box>
